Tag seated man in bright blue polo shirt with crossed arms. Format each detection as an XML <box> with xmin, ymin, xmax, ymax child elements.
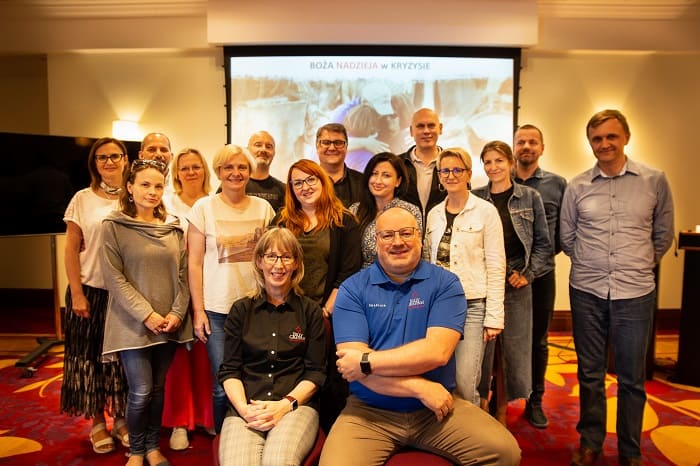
<box><xmin>320</xmin><ymin>207</ymin><xmax>520</xmax><ymax>466</ymax></box>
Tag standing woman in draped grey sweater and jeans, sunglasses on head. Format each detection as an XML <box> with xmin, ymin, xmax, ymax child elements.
<box><xmin>102</xmin><ymin>160</ymin><xmax>193</xmax><ymax>466</ymax></box>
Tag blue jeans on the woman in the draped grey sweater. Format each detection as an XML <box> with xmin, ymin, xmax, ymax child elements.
<box><xmin>119</xmin><ymin>342</ymin><xmax>177</xmax><ymax>456</ymax></box>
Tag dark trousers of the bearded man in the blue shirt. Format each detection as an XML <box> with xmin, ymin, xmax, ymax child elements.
<box><xmin>529</xmin><ymin>270</ymin><xmax>557</xmax><ymax>406</ymax></box>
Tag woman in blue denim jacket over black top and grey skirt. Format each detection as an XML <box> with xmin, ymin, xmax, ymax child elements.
<box><xmin>472</xmin><ymin>141</ymin><xmax>552</xmax><ymax>424</ymax></box>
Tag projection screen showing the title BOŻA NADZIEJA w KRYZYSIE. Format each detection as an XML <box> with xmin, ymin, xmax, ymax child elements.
<box><xmin>225</xmin><ymin>46</ymin><xmax>519</xmax><ymax>184</ymax></box>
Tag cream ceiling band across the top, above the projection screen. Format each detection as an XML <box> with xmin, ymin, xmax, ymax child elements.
<box><xmin>0</xmin><ymin>0</ymin><xmax>700</xmax><ymax>53</ymax></box>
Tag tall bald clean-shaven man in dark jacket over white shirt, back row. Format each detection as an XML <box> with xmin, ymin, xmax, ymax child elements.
<box><xmin>401</xmin><ymin>108</ymin><xmax>446</xmax><ymax>218</ymax></box>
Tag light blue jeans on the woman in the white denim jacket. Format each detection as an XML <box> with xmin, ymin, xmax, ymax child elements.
<box><xmin>455</xmin><ymin>299</ymin><xmax>486</xmax><ymax>406</ymax></box>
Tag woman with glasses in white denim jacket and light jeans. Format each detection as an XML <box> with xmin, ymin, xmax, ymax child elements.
<box><xmin>424</xmin><ymin>147</ymin><xmax>506</xmax><ymax>406</ymax></box>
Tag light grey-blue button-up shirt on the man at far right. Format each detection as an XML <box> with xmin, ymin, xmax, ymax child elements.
<box><xmin>560</xmin><ymin>158</ymin><xmax>675</xmax><ymax>299</ymax></box>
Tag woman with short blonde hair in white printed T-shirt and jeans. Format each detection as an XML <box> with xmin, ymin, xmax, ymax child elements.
<box><xmin>187</xmin><ymin>144</ymin><xmax>274</xmax><ymax>433</ymax></box>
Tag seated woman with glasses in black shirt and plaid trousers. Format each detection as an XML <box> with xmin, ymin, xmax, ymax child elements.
<box><xmin>219</xmin><ymin>228</ymin><xmax>326</xmax><ymax>466</ymax></box>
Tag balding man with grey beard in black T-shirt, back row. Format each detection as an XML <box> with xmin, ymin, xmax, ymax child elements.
<box><xmin>245</xmin><ymin>131</ymin><xmax>285</xmax><ymax>213</ymax></box>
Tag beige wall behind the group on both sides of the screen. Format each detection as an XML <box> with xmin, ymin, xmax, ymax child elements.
<box><xmin>0</xmin><ymin>49</ymin><xmax>700</xmax><ymax>309</ymax></box>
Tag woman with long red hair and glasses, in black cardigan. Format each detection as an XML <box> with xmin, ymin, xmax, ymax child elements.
<box><xmin>273</xmin><ymin>159</ymin><xmax>362</xmax><ymax>431</ymax></box>
